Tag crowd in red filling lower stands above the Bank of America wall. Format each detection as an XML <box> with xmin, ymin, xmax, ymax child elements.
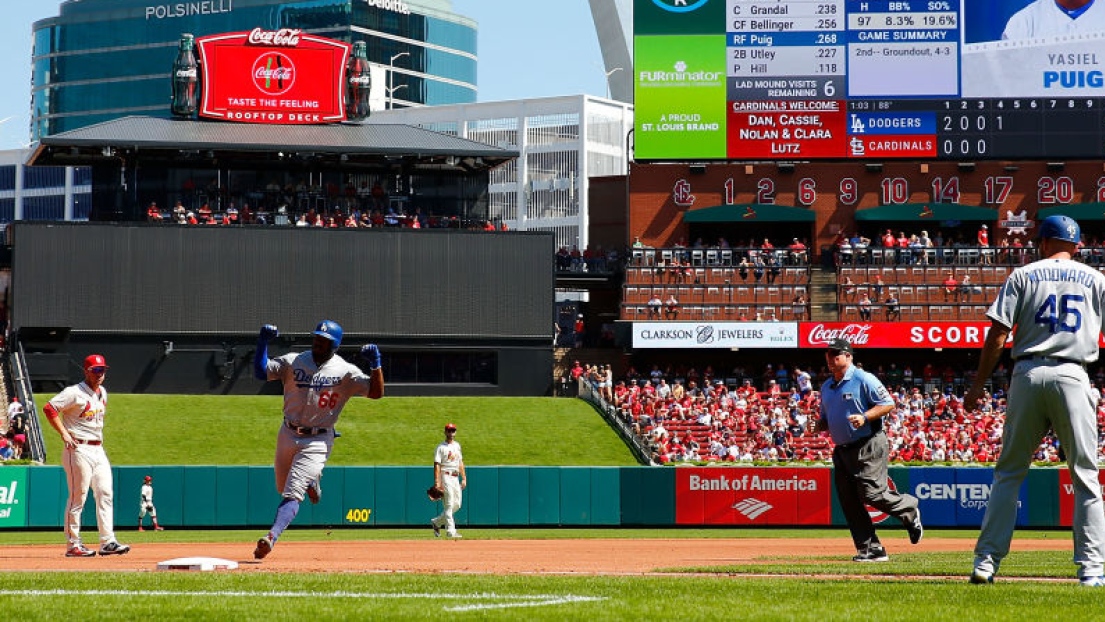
<box><xmin>570</xmin><ymin>365</ymin><xmax>1105</xmax><ymax>464</ymax></box>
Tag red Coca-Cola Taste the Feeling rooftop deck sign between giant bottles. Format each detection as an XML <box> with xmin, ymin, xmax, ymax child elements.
<box><xmin>197</xmin><ymin>28</ymin><xmax>351</xmax><ymax>124</ymax></box>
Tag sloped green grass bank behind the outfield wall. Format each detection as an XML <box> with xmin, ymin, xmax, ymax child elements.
<box><xmin>35</xmin><ymin>397</ymin><xmax>636</xmax><ymax>466</ymax></box>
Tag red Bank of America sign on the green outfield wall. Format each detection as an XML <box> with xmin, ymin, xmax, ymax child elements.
<box><xmin>675</xmin><ymin>467</ymin><xmax>832</xmax><ymax>525</ymax></box>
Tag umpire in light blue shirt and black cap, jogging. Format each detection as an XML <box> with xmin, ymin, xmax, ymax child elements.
<box><xmin>818</xmin><ymin>339</ymin><xmax>925</xmax><ymax>561</ymax></box>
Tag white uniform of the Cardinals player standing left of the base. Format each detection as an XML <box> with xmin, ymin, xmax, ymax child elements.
<box><xmin>50</xmin><ymin>382</ymin><xmax>115</xmax><ymax>547</ymax></box>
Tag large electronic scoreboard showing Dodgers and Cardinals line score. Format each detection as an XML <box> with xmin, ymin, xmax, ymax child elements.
<box><xmin>634</xmin><ymin>0</ymin><xmax>1105</xmax><ymax>160</ymax></box>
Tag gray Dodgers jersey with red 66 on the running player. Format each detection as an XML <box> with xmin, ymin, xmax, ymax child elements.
<box><xmin>266</xmin><ymin>350</ymin><xmax>371</xmax><ymax>428</ymax></box>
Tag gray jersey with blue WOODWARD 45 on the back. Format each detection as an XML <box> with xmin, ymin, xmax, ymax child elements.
<box><xmin>986</xmin><ymin>260</ymin><xmax>1105</xmax><ymax>362</ymax></box>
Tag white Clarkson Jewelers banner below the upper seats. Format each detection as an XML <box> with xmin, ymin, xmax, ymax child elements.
<box><xmin>633</xmin><ymin>321</ymin><xmax>798</xmax><ymax>348</ymax></box>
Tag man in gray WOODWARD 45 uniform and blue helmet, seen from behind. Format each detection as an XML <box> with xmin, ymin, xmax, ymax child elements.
<box><xmin>964</xmin><ymin>215</ymin><xmax>1105</xmax><ymax>587</ymax></box>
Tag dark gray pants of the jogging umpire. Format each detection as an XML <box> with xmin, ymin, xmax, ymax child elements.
<box><xmin>832</xmin><ymin>431</ymin><xmax>917</xmax><ymax>551</ymax></box>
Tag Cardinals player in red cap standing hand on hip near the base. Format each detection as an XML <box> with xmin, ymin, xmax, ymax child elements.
<box><xmin>42</xmin><ymin>355</ymin><xmax>130</xmax><ymax>557</ymax></box>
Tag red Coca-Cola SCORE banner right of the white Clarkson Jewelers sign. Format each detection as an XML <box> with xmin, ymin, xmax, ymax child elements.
<box><xmin>798</xmin><ymin>321</ymin><xmax>990</xmax><ymax>348</ymax></box>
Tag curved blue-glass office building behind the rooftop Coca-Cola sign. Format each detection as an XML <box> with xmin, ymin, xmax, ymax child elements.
<box><xmin>31</xmin><ymin>0</ymin><xmax>476</xmax><ymax>140</ymax></box>
